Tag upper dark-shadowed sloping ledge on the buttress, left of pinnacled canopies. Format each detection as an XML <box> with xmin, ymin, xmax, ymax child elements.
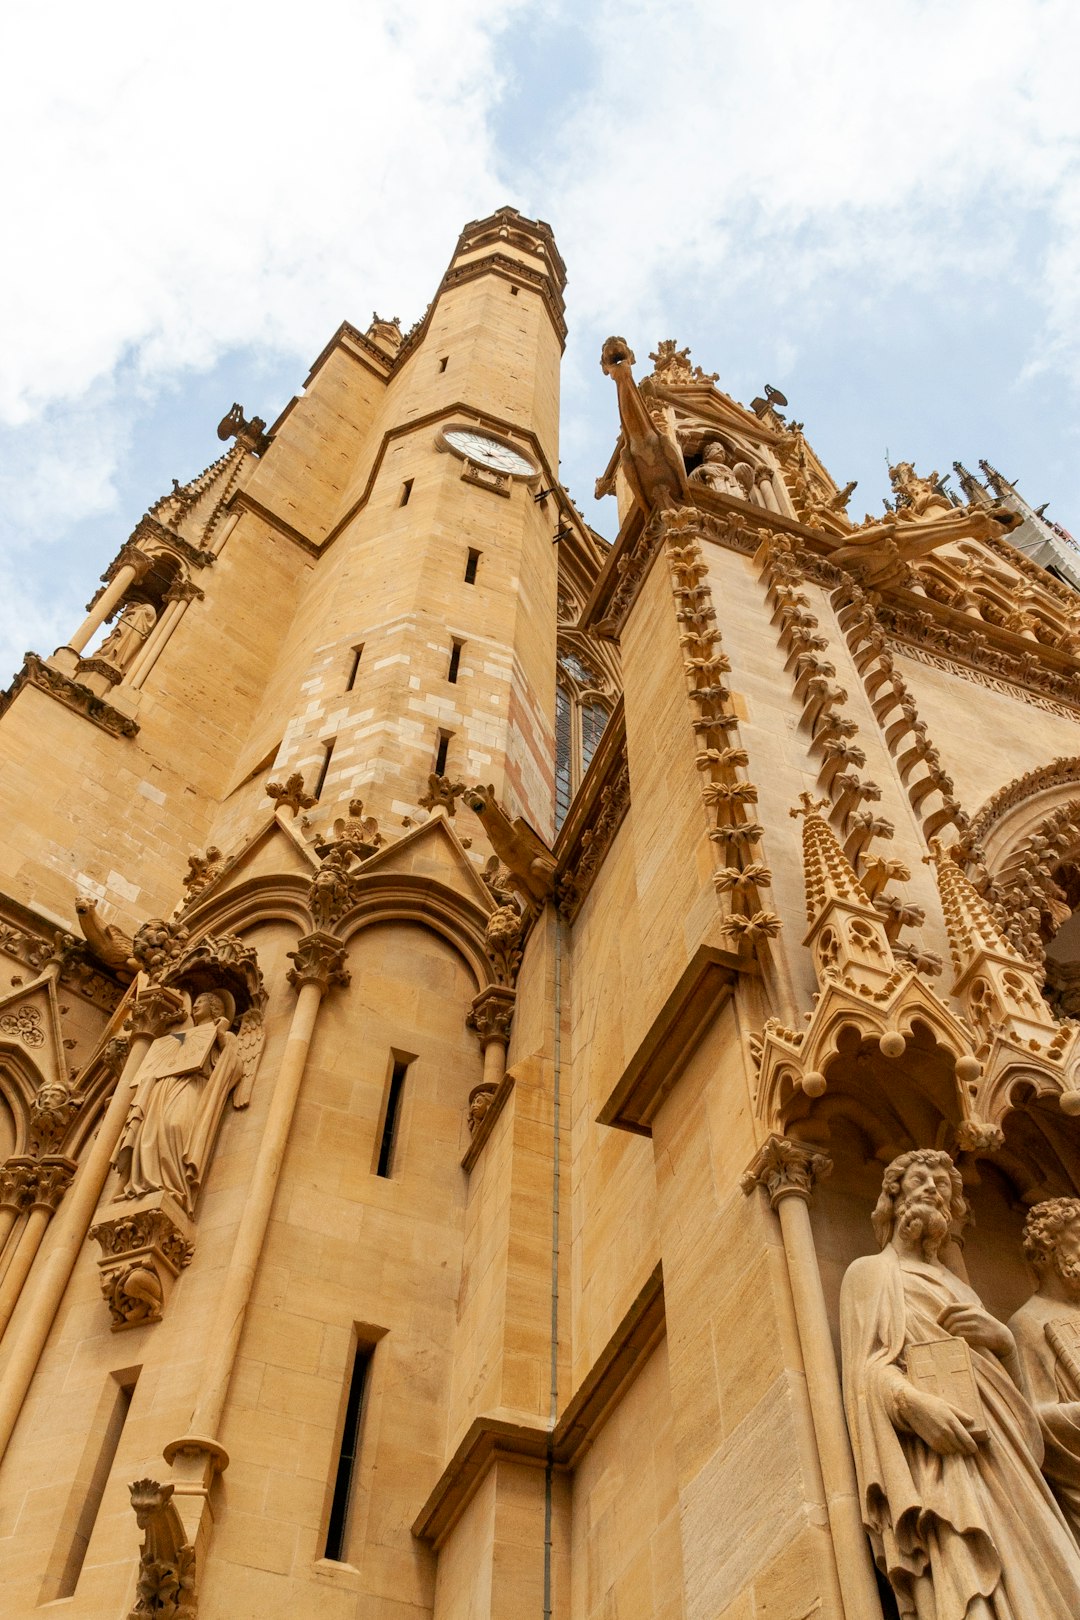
<box><xmin>596</xmin><ymin>944</ymin><xmax>751</xmax><ymax>1136</ymax></box>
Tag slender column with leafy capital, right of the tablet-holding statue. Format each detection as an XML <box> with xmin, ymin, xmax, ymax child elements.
<box><xmin>164</xmin><ymin>933</ymin><xmax>350</xmax><ymax>1558</ymax></box>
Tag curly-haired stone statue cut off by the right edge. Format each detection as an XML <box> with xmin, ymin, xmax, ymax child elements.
<box><xmin>1009</xmin><ymin>1199</ymin><xmax>1080</xmax><ymax>1541</ymax></box>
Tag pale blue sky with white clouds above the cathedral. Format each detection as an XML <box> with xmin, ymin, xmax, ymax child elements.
<box><xmin>0</xmin><ymin>0</ymin><xmax>1080</xmax><ymax>687</ymax></box>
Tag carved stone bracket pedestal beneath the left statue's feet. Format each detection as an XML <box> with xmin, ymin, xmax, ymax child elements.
<box><xmin>91</xmin><ymin>1192</ymin><xmax>194</xmax><ymax>1333</ymax></box>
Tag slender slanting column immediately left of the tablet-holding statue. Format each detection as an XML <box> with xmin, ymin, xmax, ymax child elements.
<box><xmin>0</xmin><ymin>985</ymin><xmax>185</xmax><ymax>1458</ymax></box>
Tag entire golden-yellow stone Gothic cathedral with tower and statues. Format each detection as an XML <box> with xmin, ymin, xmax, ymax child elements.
<box><xmin>0</xmin><ymin>209</ymin><xmax>1080</xmax><ymax>1620</ymax></box>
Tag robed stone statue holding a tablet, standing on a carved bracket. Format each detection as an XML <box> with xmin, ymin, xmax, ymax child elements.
<box><xmin>113</xmin><ymin>990</ymin><xmax>262</xmax><ymax>1215</ymax></box>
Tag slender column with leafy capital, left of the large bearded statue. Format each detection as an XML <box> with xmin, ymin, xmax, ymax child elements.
<box><xmin>743</xmin><ymin>1136</ymin><xmax>881</xmax><ymax>1620</ymax></box>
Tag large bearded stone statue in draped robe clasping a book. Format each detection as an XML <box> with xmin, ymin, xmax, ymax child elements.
<box><xmin>840</xmin><ymin>1149</ymin><xmax>1080</xmax><ymax>1620</ymax></box>
